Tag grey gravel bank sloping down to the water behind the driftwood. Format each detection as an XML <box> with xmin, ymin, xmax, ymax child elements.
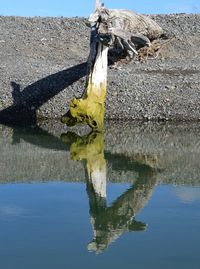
<box><xmin>0</xmin><ymin>14</ymin><xmax>200</xmax><ymax>122</ymax></box>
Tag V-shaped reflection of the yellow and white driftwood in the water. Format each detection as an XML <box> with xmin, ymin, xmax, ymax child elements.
<box><xmin>61</xmin><ymin>132</ymin><xmax>156</xmax><ymax>253</ymax></box>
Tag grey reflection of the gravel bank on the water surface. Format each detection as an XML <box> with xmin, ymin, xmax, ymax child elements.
<box><xmin>0</xmin><ymin>122</ymin><xmax>200</xmax><ymax>186</ymax></box>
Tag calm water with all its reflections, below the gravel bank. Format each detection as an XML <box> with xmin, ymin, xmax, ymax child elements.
<box><xmin>0</xmin><ymin>123</ymin><xmax>200</xmax><ymax>269</ymax></box>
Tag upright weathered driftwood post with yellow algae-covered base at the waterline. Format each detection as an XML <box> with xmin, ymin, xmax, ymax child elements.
<box><xmin>61</xmin><ymin>0</ymin><xmax>110</xmax><ymax>132</ymax></box>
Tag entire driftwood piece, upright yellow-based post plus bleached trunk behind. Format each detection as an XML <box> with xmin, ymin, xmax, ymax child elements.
<box><xmin>61</xmin><ymin>0</ymin><xmax>163</xmax><ymax>132</ymax></box>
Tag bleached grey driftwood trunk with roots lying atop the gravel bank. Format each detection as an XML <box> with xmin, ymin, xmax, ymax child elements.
<box><xmin>89</xmin><ymin>3</ymin><xmax>163</xmax><ymax>58</ymax></box>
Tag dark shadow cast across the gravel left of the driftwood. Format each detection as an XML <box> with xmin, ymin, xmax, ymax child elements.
<box><xmin>0</xmin><ymin>62</ymin><xmax>87</xmax><ymax>126</ymax></box>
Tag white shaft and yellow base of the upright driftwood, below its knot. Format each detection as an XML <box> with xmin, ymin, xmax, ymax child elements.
<box><xmin>61</xmin><ymin>42</ymin><xmax>108</xmax><ymax>132</ymax></box>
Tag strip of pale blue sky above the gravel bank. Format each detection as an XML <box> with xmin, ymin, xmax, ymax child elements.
<box><xmin>0</xmin><ymin>0</ymin><xmax>200</xmax><ymax>17</ymax></box>
